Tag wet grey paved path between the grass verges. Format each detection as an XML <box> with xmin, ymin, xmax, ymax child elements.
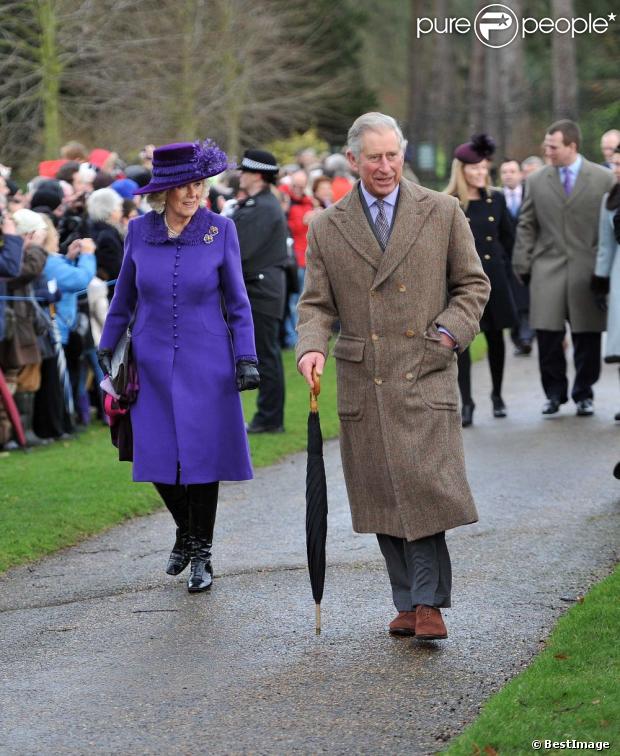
<box><xmin>0</xmin><ymin>346</ymin><xmax>620</xmax><ymax>755</ymax></box>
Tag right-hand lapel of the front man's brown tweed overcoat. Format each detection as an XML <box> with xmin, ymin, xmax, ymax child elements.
<box><xmin>372</xmin><ymin>181</ymin><xmax>435</xmax><ymax>289</ymax></box>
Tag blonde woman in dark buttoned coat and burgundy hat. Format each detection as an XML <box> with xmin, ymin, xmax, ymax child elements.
<box><xmin>446</xmin><ymin>134</ymin><xmax>518</xmax><ymax>427</ymax></box>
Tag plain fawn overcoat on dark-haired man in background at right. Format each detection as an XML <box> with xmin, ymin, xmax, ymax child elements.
<box><xmin>512</xmin><ymin>159</ymin><xmax>614</xmax><ymax>333</ymax></box>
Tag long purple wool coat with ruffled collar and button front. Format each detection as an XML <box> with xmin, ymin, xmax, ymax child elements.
<box><xmin>100</xmin><ymin>209</ymin><xmax>256</xmax><ymax>484</ymax></box>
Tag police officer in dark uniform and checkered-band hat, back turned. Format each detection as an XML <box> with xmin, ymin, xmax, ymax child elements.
<box><xmin>232</xmin><ymin>150</ymin><xmax>287</xmax><ymax>433</ymax></box>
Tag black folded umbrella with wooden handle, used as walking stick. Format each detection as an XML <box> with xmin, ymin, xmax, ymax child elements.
<box><xmin>306</xmin><ymin>373</ymin><xmax>327</xmax><ymax>635</ymax></box>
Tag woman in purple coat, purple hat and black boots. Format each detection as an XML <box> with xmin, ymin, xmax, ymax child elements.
<box><xmin>99</xmin><ymin>141</ymin><xmax>259</xmax><ymax>593</ymax></box>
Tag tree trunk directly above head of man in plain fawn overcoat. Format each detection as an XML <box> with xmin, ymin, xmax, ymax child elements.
<box><xmin>551</xmin><ymin>0</ymin><xmax>578</xmax><ymax>120</ymax></box>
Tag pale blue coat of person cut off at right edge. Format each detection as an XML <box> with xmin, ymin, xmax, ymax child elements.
<box><xmin>594</xmin><ymin>194</ymin><xmax>620</xmax><ymax>362</ymax></box>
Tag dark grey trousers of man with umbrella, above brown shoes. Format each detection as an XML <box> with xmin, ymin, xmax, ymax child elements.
<box><xmin>377</xmin><ymin>533</ymin><xmax>452</xmax><ymax>612</ymax></box>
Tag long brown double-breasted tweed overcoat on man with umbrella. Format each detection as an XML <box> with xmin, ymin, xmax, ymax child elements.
<box><xmin>296</xmin><ymin>179</ymin><xmax>490</xmax><ymax>540</ymax></box>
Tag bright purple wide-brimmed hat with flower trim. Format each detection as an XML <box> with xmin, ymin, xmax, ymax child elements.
<box><xmin>134</xmin><ymin>139</ymin><xmax>229</xmax><ymax>194</ymax></box>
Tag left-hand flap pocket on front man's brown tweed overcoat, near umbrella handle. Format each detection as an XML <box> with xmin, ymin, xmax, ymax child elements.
<box><xmin>333</xmin><ymin>334</ymin><xmax>368</xmax><ymax>420</ymax></box>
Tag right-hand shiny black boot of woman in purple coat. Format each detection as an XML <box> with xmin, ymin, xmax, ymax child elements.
<box><xmin>187</xmin><ymin>481</ymin><xmax>220</xmax><ymax>593</ymax></box>
